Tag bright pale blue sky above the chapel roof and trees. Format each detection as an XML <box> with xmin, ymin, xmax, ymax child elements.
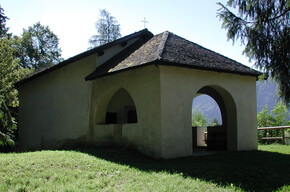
<box><xmin>0</xmin><ymin>0</ymin><xmax>253</xmax><ymax>67</ymax></box>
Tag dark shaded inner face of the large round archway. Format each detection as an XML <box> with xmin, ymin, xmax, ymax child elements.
<box><xmin>193</xmin><ymin>85</ymin><xmax>237</xmax><ymax>151</ymax></box>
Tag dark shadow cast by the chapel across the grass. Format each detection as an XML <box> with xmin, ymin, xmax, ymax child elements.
<box><xmin>78</xmin><ymin>148</ymin><xmax>290</xmax><ymax>191</ymax></box>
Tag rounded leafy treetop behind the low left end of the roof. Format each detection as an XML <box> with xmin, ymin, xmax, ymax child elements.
<box><xmin>17</xmin><ymin>22</ymin><xmax>62</xmax><ymax>69</ymax></box>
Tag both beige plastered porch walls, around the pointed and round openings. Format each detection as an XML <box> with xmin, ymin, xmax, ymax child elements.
<box><xmin>89</xmin><ymin>65</ymin><xmax>257</xmax><ymax>159</ymax></box>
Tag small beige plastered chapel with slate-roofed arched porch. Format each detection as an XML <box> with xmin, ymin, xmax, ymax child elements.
<box><xmin>16</xmin><ymin>29</ymin><xmax>261</xmax><ymax>159</ymax></box>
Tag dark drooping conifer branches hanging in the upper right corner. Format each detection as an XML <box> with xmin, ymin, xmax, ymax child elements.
<box><xmin>218</xmin><ymin>0</ymin><xmax>290</xmax><ymax>104</ymax></box>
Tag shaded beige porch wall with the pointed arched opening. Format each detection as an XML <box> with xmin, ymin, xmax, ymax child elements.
<box><xmin>89</xmin><ymin>65</ymin><xmax>161</xmax><ymax>158</ymax></box>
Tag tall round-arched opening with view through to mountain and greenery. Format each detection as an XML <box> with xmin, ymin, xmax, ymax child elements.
<box><xmin>192</xmin><ymin>86</ymin><xmax>237</xmax><ymax>151</ymax></box>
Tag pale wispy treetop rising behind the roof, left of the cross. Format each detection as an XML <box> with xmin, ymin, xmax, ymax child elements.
<box><xmin>89</xmin><ymin>9</ymin><xmax>121</xmax><ymax>48</ymax></box>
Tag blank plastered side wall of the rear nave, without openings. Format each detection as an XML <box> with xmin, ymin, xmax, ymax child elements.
<box><xmin>18</xmin><ymin>38</ymin><xmax>137</xmax><ymax>149</ymax></box>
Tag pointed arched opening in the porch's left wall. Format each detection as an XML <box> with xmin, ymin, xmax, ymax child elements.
<box><xmin>105</xmin><ymin>89</ymin><xmax>137</xmax><ymax>124</ymax></box>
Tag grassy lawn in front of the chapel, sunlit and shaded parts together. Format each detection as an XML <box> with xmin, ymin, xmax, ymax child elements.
<box><xmin>0</xmin><ymin>145</ymin><xmax>290</xmax><ymax>191</ymax></box>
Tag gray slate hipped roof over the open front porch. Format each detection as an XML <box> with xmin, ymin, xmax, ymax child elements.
<box><xmin>108</xmin><ymin>31</ymin><xmax>261</xmax><ymax>77</ymax></box>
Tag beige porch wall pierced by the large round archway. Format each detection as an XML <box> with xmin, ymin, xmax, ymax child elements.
<box><xmin>159</xmin><ymin>66</ymin><xmax>257</xmax><ymax>158</ymax></box>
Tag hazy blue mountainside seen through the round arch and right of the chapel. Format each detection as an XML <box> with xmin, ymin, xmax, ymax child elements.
<box><xmin>192</xmin><ymin>81</ymin><xmax>286</xmax><ymax>122</ymax></box>
